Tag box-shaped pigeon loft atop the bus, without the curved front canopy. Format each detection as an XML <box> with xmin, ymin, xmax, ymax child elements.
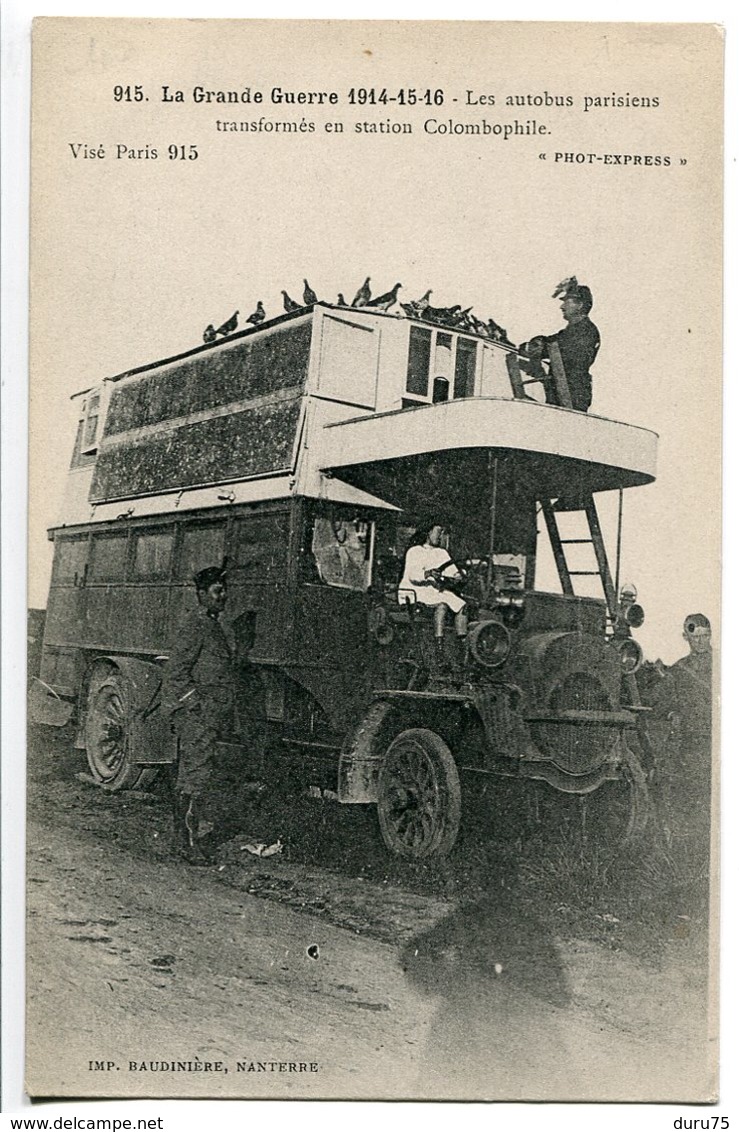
<box><xmin>63</xmin><ymin>305</ymin><xmax>513</xmax><ymax>513</ymax></box>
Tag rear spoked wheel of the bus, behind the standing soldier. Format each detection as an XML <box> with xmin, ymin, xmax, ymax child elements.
<box><xmin>85</xmin><ymin>669</ymin><xmax>156</xmax><ymax>792</ymax></box>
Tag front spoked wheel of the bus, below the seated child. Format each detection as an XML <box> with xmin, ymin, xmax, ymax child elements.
<box><xmin>377</xmin><ymin>728</ymin><xmax>462</xmax><ymax>858</ymax></box>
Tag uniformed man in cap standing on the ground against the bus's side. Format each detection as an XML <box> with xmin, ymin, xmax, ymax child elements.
<box><xmin>163</xmin><ymin>566</ymin><xmax>234</xmax><ymax>865</ymax></box>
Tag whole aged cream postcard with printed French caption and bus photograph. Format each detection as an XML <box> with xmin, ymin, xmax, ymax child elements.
<box><xmin>26</xmin><ymin>18</ymin><xmax>723</xmax><ymax>1103</ymax></box>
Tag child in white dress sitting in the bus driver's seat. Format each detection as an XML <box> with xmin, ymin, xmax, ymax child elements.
<box><xmin>398</xmin><ymin>522</ymin><xmax>467</xmax><ymax>644</ymax></box>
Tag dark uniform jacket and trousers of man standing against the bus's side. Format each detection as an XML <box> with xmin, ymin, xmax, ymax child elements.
<box><xmin>162</xmin><ymin>606</ymin><xmax>234</xmax><ymax>798</ymax></box>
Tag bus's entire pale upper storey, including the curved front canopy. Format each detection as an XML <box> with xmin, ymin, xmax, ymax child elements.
<box><xmin>54</xmin><ymin>303</ymin><xmax>656</xmax><ymax>526</ymax></box>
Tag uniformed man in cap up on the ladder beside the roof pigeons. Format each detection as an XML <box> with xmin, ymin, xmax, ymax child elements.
<box><xmin>521</xmin><ymin>275</ymin><xmax>601</xmax><ymax>412</ymax></box>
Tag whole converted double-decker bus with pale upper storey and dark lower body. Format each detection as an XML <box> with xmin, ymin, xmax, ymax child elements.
<box><xmin>37</xmin><ymin>302</ymin><xmax>656</xmax><ymax>858</ymax></box>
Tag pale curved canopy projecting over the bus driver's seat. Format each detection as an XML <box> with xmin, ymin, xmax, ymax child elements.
<box><xmin>321</xmin><ymin>397</ymin><xmax>658</xmax><ymax>507</ymax></box>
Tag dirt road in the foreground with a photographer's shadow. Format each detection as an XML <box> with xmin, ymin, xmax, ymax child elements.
<box><xmin>27</xmin><ymin>730</ymin><xmax>712</xmax><ymax>1100</ymax></box>
